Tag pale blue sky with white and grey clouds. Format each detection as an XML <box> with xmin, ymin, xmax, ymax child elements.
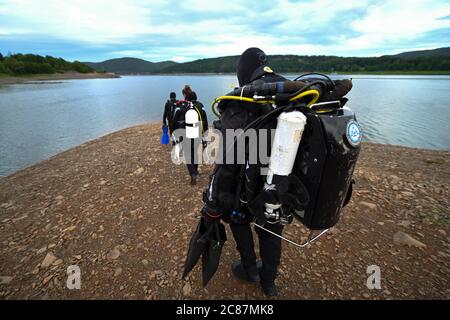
<box><xmin>0</xmin><ymin>0</ymin><xmax>450</xmax><ymax>62</ymax></box>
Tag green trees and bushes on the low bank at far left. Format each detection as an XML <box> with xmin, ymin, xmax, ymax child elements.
<box><xmin>0</xmin><ymin>53</ymin><xmax>95</xmax><ymax>76</ymax></box>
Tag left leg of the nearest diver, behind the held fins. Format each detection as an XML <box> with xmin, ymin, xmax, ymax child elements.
<box><xmin>230</xmin><ymin>222</ymin><xmax>258</xmax><ymax>274</ymax></box>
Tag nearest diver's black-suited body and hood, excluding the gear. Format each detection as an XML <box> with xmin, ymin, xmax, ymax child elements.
<box><xmin>203</xmin><ymin>48</ymin><xmax>286</xmax><ymax>297</ymax></box>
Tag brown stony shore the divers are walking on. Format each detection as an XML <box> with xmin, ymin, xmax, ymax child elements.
<box><xmin>0</xmin><ymin>125</ymin><xmax>450</xmax><ymax>299</ymax></box>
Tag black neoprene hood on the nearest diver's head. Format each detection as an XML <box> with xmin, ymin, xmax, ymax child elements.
<box><xmin>237</xmin><ymin>48</ymin><xmax>268</xmax><ymax>87</ymax></box>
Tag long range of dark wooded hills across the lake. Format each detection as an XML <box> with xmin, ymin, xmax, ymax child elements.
<box><xmin>86</xmin><ymin>48</ymin><xmax>450</xmax><ymax>74</ymax></box>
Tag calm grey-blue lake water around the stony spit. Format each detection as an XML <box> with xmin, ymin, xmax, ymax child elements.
<box><xmin>0</xmin><ymin>75</ymin><xmax>450</xmax><ymax>176</ymax></box>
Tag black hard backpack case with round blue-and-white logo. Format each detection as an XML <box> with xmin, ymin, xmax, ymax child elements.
<box><xmin>293</xmin><ymin>107</ymin><xmax>362</xmax><ymax>230</ymax></box>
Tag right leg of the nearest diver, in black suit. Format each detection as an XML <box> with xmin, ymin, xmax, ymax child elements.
<box><xmin>256</xmin><ymin>223</ymin><xmax>283</xmax><ymax>287</ymax></box>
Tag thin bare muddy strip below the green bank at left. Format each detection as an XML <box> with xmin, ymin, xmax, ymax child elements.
<box><xmin>0</xmin><ymin>72</ymin><xmax>120</xmax><ymax>85</ymax></box>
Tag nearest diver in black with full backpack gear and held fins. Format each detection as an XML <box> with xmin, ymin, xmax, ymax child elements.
<box><xmin>183</xmin><ymin>48</ymin><xmax>362</xmax><ymax>297</ymax></box>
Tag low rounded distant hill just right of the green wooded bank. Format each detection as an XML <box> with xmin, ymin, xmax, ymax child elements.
<box><xmin>84</xmin><ymin>58</ymin><xmax>177</xmax><ymax>74</ymax></box>
